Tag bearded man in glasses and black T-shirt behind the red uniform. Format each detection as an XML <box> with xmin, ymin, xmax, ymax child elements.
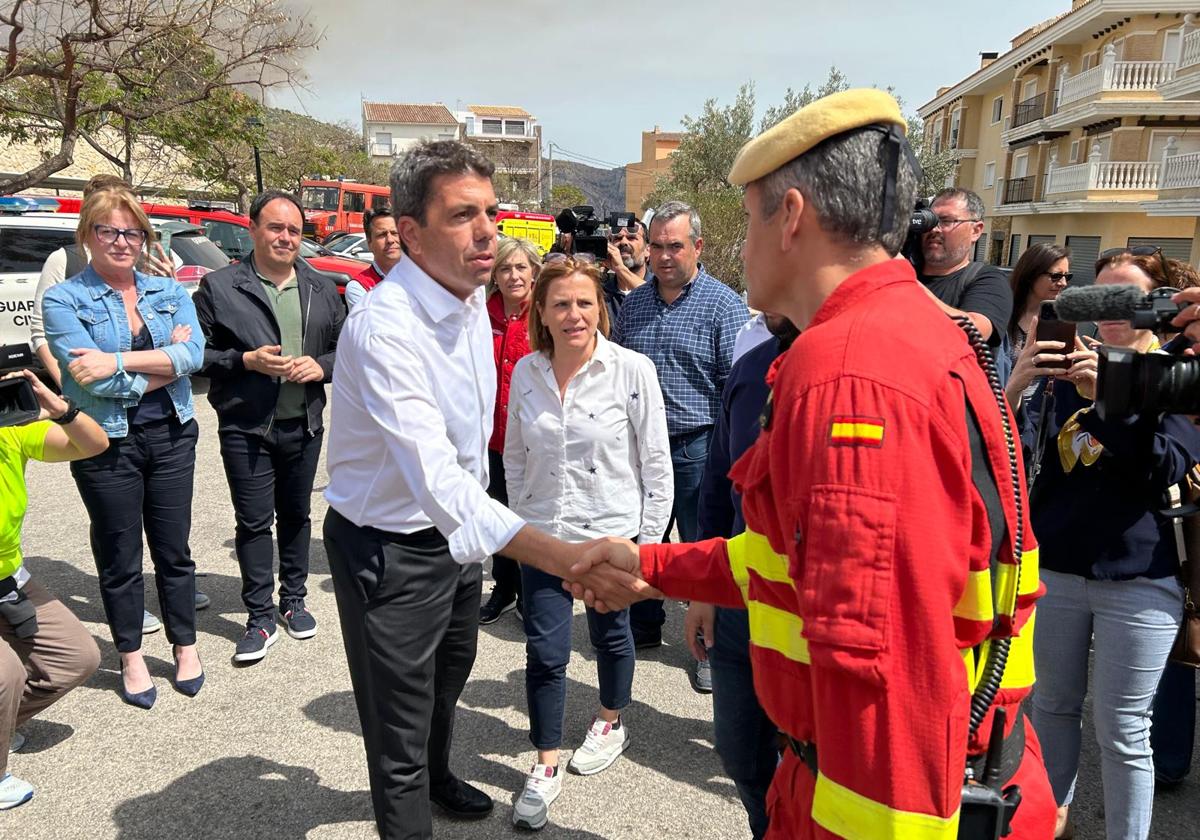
<box><xmin>920</xmin><ymin>187</ymin><xmax>1013</xmax><ymax>347</ymax></box>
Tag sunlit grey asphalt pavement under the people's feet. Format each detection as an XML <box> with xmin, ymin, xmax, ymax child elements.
<box><xmin>9</xmin><ymin>397</ymin><xmax>1200</xmax><ymax>840</ymax></box>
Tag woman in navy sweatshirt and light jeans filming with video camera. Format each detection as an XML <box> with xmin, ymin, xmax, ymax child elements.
<box><xmin>1018</xmin><ymin>250</ymin><xmax>1200</xmax><ymax>838</ymax></box>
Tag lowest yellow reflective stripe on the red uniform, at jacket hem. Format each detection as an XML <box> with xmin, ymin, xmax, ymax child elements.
<box><xmin>812</xmin><ymin>773</ymin><xmax>959</xmax><ymax>840</ymax></box>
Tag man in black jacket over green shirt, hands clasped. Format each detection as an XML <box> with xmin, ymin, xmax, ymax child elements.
<box><xmin>194</xmin><ymin>190</ymin><xmax>346</xmax><ymax>662</ymax></box>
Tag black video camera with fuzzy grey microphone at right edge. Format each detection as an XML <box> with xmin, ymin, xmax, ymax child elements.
<box><xmin>1054</xmin><ymin>286</ymin><xmax>1200</xmax><ymax>419</ymax></box>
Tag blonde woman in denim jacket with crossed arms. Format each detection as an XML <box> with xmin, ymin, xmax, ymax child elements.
<box><xmin>43</xmin><ymin>190</ymin><xmax>204</xmax><ymax>709</ymax></box>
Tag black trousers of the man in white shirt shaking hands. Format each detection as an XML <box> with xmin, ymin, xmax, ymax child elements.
<box><xmin>325</xmin><ymin>508</ymin><xmax>482</xmax><ymax>840</ymax></box>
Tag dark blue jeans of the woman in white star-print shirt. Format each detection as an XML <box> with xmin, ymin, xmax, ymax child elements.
<box><xmin>521</xmin><ymin>565</ymin><xmax>636</xmax><ymax>750</ymax></box>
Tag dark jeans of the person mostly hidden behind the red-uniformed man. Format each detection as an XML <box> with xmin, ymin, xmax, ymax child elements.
<box><xmin>708</xmin><ymin>607</ymin><xmax>779</xmax><ymax>840</ymax></box>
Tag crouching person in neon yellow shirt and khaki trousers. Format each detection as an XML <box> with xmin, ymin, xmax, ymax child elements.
<box><xmin>0</xmin><ymin>371</ymin><xmax>108</xmax><ymax>810</ymax></box>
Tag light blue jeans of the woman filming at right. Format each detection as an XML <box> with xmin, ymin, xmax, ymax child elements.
<box><xmin>1033</xmin><ymin>570</ymin><xmax>1183</xmax><ymax>840</ymax></box>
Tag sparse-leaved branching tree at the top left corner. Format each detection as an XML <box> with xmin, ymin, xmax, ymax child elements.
<box><xmin>0</xmin><ymin>0</ymin><xmax>319</xmax><ymax>194</ymax></box>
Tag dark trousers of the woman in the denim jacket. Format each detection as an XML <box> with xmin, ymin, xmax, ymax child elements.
<box><xmin>71</xmin><ymin>418</ymin><xmax>199</xmax><ymax>653</ymax></box>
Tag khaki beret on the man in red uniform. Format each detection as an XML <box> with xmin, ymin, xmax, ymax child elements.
<box><xmin>728</xmin><ymin>88</ymin><xmax>908</xmax><ymax>186</ymax></box>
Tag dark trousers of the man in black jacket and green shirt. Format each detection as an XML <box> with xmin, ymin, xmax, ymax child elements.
<box><xmin>221</xmin><ymin>418</ymin><xmax>323</xmax><ymax>620</ymax></box>
